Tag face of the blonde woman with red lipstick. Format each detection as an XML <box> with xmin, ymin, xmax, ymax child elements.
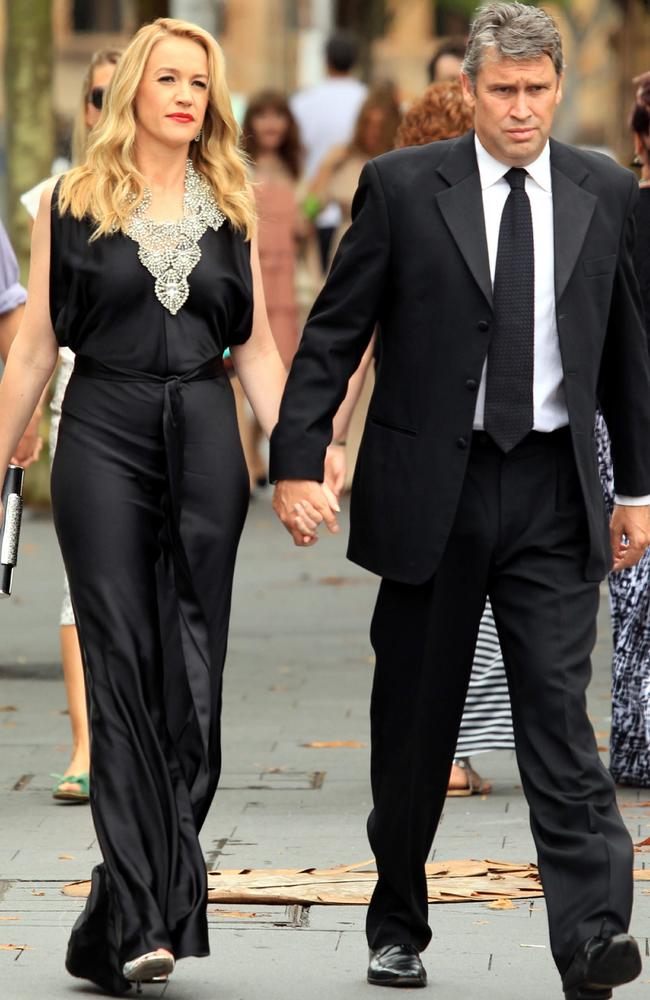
<box><xmin>135</xmin><ymin>35</ymin><xmax>208</xmax><ymax>147</ymax></box>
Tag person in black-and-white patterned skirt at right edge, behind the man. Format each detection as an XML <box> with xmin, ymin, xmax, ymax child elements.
<box><xmin>596</xmin><ymin>72</ymin><xmax>650</xmax><ymax>788</ymax></box>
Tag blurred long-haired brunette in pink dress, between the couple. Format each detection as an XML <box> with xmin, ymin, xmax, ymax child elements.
<box><xmin>238</xmin><ymin>90</ymin><xmax>308</xmax><ymax>493</ymax></box>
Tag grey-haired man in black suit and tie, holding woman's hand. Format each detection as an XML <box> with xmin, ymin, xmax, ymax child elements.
<box><xmin>271</xmin><ymin>3</ymin><xmax>650</xmax><ymax>1000</ymax></box>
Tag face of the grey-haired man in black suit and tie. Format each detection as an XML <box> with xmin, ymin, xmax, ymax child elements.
<box><xmin>461</xmin><ymin>52</ymin><xmax>562</xmax><ymax>167</ymax></box>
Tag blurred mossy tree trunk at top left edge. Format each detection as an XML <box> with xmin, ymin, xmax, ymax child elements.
<box><xmin>5</xmin><ymin>0</ymin><xmax>54</xmax><ymax>276</ymax></box>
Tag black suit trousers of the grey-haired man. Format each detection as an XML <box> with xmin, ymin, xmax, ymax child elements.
<box><xmin>367</xmin><ymin>429</ymin><xmax>633</xmax><ymax>972</ymax></box>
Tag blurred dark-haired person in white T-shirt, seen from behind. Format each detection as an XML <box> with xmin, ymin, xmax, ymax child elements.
<box><xmin>290</xmin><ymin>31</ymin><xmax>367</xmax><ymax>273</ymax></box>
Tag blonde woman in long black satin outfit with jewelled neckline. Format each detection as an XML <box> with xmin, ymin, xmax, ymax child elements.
<box><xmin>0</xmin><ymin>19</ymin><xmax>298</xmax><ymax>994</ymax></box>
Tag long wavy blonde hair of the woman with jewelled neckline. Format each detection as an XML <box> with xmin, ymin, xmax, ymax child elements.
<box><xmin>59</xmin><ymin>17</ymin><xmax>255</xmax><ymax>240</ymax></box>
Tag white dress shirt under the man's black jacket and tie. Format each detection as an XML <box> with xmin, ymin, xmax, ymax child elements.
<box><xmin>474</xmin><ymin>136</ymin><xmax>650</xmax><ymax>506</ymax></box>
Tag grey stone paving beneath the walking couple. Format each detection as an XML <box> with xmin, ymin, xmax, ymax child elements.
<box><xmin>0</xmin><ymin>497</ymin><xmax>650</xmax><ymax>1000</ymax></box>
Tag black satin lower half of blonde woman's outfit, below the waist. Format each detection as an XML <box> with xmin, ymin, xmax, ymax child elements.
<box><xmin>52</xmin><ymin>361</ymin><xmax>248</xmax><ymax>992</ymax></box>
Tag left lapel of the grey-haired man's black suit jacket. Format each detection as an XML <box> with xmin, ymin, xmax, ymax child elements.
<box><xmin>436</xmin><ymin>130</ymin><xmax>492</xmax><ymax>306</ymax></box>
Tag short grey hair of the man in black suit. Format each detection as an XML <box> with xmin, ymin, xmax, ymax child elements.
<box><xmin>463</xmin><ymin>3</ymin><xmax>564</xmax><ymax>86</ymax></box>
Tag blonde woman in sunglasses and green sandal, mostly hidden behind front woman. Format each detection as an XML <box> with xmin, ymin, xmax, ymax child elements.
<box><xmin>20</xmin><ymin>49</ymin><xmax>121</xmax><ymax>802</ymax></box>
